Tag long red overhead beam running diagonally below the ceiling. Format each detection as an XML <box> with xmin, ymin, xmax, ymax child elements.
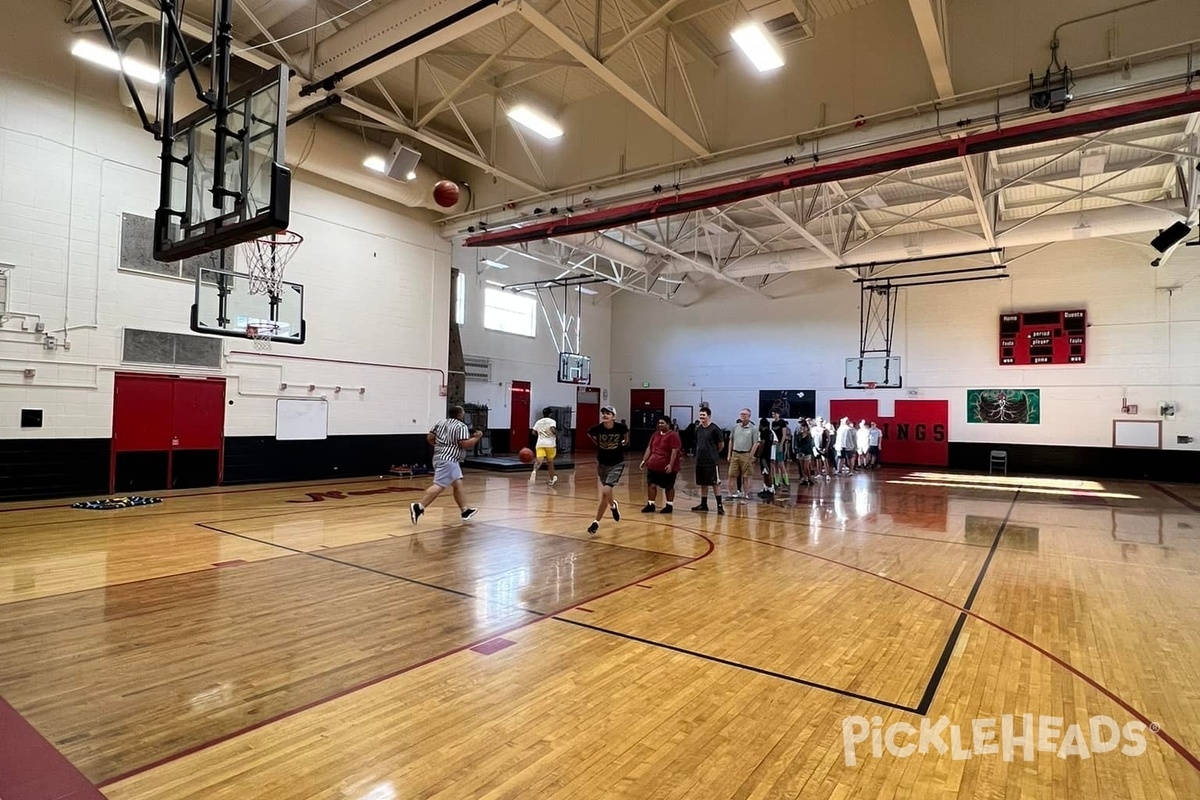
<box><xmin>464</xmin><ymin>91</ymin><xmax>1200</xmax><ymax>247</ymax></box>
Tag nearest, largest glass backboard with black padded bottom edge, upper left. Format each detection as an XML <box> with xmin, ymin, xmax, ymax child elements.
<box><xmin>154</xmin><ymin>65</ymin><xmax>292</xmax><ymax>261</ymax></box>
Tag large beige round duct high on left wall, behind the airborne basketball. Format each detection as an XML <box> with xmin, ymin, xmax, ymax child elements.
<box><xmin>287</xmin><ymin>118</ymin><xmax>469</xmax><ymax>213</ymax></box>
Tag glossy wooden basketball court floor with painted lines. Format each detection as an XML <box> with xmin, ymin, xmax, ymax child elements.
<box><xmin>0</xmin><ymin>458</ymin><xmax>1200</xmax><ymax>800</ymax></box>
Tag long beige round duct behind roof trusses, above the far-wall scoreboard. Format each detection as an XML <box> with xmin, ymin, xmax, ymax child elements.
<box><xmin>715</xmin><ymin>200</ymin><xmax>1182</xmax><ymax>278</ymax></box>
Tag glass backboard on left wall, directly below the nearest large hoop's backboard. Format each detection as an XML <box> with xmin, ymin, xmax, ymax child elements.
<box><xmin>191</xmin><ymin>270</ymin><xmax>305</xmax><ymax>344</ymax></box>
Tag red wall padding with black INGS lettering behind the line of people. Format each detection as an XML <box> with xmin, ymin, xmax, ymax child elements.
<box><xmin>829</xmin><ymin>399</ymin><xmax>950</xmax><ymax>467</ymax></box>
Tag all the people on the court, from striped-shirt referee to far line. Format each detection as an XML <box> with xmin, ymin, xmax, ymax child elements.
<box><xmin>409</xmin><ymin>405</ymin><xmax>883</xmax><ymax>535</ymax></box>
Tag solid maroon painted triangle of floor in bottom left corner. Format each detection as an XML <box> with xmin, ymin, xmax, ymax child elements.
<box><xmin>0</xmin><ymin>698</ymin><xmax>104</xmax><ymax>800</ymax></box>
